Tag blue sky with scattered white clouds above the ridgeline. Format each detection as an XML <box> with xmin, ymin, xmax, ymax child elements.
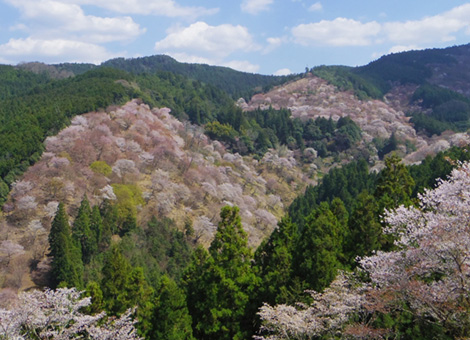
<box><xmin>0</xmin><ymin>0</ymin><xmax>470</xmax><ymax>74</ymax></box>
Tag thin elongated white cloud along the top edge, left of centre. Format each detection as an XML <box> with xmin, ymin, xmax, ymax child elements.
<box><xmin>58</xmin><ymin>0</ymin><xmax>219</xmax><ymax>19</ymax></box>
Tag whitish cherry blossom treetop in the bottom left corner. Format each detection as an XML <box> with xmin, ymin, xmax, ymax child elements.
<box><xmin>0</xmin><ymin>288</ymin><xmax>142</xmax><ymax>340</ymax></box>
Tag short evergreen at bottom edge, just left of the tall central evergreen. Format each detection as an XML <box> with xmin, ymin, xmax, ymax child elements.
<box><xmin>148</xmin><ymin>275</ymin><xmax>194</xmax><ymax>340</ymax></box>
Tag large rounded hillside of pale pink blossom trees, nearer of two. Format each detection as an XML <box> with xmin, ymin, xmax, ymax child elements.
<box><xmin>0</xmin><ymin>101</ymin><xmax>313</xmax><ymax>286</ymax></box>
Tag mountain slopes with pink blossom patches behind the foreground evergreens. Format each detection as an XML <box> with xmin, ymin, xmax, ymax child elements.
<box><xmin>0</xmin><ymin>42</ymin><xmax>470</xmax><ymax>290</ymax></box>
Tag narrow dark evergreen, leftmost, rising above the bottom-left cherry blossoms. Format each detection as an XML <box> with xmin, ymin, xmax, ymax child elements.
<box><xmin>49</xmin><ymin>203</ymin><xmax>83</xmax><ymax>288</ymax></box>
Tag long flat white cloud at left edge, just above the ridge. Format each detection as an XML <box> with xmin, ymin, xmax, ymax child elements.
<box><xmin>0</xmin><ymin>37</ymin><xmax>116</xmax><ymax>64</ymax></box>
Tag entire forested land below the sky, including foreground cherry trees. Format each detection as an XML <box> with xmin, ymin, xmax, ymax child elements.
<box><xmin>0</xmin><ymin>46</ymin><xmax>470</xmax><ymax>340</ymax></box>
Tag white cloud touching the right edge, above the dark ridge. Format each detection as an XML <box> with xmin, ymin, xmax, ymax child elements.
<box><xmin>384</xmin><ymin>4</ymin><xmax>470</xmax><ymax>45</ymax></box>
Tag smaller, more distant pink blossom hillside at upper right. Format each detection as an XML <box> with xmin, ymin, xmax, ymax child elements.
<box><xmin>242</xmin><ymin>75</ymin><xmax>470</xmax><ymax>163</ymax></box>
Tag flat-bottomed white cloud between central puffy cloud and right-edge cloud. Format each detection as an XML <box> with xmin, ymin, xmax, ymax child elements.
<box><xmin>291</xmin><ymin>18</ymin><xmax>381</xmax><ymax>46</ymax></box>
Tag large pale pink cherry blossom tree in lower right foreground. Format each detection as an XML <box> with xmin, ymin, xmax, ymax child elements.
<box><xmin>258</xmin><ymin>163</ymin><xmax>470</xmax><ymax>339</ymax></box>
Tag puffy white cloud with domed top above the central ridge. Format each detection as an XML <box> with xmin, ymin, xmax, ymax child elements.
<box><xmin>155</xmin><ymin>21</ymin><xmax>259</xmax><ymax>59</ymax></box>
